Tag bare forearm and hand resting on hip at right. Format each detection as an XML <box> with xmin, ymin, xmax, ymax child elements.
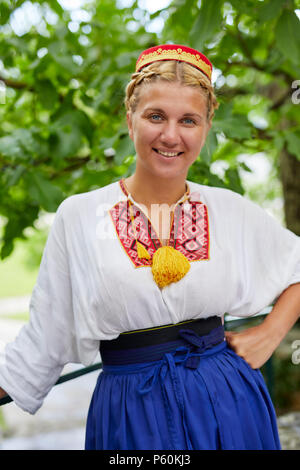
<box><xmin>225</xmin><ymin>283</ymin><xmax>300</xmax><ymax>369</ymax></box>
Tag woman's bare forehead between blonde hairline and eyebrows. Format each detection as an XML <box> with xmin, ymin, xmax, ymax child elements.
<box><xmin>136</xmin><ymin>80</ymin><xmax>207</xmax><ymax>114</ymax></box>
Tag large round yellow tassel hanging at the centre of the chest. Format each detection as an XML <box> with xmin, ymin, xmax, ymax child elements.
<box><xmin>152</xmin><ymin>246</ymin><xmax>190</xmax><ymax>288</ymax></box>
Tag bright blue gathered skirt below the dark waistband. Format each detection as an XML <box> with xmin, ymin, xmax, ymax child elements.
<box><xmin>85</xmin><ymin>324</ymin><xmax>281</xmax><ymax>450</ymax></box>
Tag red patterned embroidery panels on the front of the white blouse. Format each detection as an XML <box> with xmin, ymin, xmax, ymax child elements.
<box><xmin>109</xmin><ymin>180</ymin><xmax>209</xmax><ymax>267</ymax></box>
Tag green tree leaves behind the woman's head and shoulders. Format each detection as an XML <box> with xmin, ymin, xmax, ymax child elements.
<box><xmin>0</xmin><ymin>0</ymin><xmax>300</xmax><ymax>259</ymax></box>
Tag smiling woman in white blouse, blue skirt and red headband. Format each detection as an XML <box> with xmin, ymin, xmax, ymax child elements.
<box><xmin>0</xmin><ymin>45</ymin><xmax>300</xmax><ymax>450</ymax></box>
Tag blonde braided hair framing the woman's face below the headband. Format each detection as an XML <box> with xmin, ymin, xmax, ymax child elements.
<box><xmin>124</xmin><ymin>60</ymin><xmax>219</xmax><ymax>121</ymax></box>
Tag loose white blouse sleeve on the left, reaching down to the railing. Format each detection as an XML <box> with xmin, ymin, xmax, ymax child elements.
<box><xmin>0</xmin><ymin>201</ymin><xmax>80</xmax><ymax>414</ymax></box>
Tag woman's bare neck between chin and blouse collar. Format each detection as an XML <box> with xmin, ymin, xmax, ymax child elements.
<box><xmin>124</xmin><ymin>172</ymin><xmax>187</xmax><ymax>207</ymax></box>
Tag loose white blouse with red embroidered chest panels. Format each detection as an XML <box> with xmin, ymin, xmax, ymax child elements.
<box><xmin>0</xmin><ymin>181</ymin><xmax>300</xmax><ymax>414</ymax></box>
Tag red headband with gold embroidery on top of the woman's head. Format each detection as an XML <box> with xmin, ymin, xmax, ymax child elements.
<box><xmin>135</xmin><ymin>44</ymin><xmax>212</xmax><ymax>80</ymax></box>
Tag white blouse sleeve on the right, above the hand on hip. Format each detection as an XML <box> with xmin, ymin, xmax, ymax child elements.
<box><xmin>228</xmin><ymin>196</ymin><xmax>300</xmax><ymax>317</ymax></box>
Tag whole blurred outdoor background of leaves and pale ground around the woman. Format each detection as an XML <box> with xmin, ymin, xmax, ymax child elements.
<box><xmin>0</xmin><ymin>0</ymin><xmax>300</xmax><ymax>449</ymax></box>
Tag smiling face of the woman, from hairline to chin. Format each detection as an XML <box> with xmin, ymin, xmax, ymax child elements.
<box><xmin>127</xmin><ymin>80</ymin><xmax>211</xmax><ymax>178</ymax></box>
